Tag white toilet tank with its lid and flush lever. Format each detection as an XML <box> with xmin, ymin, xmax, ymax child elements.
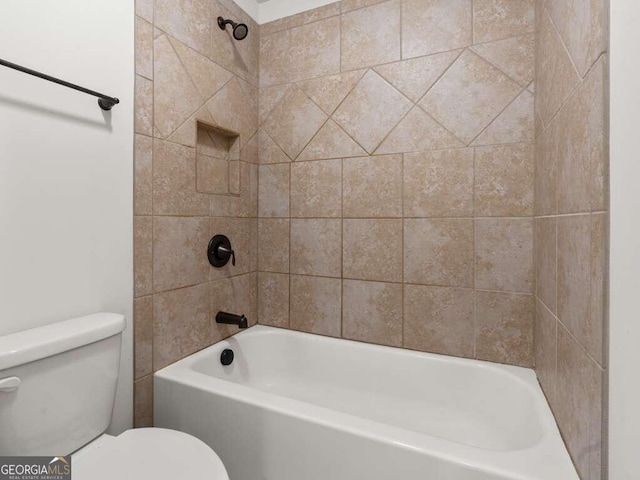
<box><xmin>0</xmin><ymin>313</ymin><xmax>126</xmax><ymax>456</ymax></box>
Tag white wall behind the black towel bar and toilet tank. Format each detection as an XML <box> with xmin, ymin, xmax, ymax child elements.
<box><xmin>0</xmin><ymin>0</ymin><xmax>134</xmax><ymax>432</ymax></box>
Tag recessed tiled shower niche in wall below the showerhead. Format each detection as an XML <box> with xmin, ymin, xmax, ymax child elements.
<box><xmin>196</xmin><ymin>120</ymin><xmax>240</xmax><ymax>196</ymax></box>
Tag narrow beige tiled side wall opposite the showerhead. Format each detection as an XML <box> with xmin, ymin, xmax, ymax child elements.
<box><xmin>535</xmin><ymin>0</ymin><xmax>608</xmax><ymax>480</ymax></box>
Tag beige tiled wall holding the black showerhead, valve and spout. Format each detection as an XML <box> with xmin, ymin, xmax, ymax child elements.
<box><xmin>134</xmin><ymin>0</ymin><xmax>259</xmax><ymax>426</ymax></box>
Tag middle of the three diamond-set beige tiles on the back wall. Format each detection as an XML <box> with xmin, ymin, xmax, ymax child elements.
<box><xmin>333</xmin><ymin>71</ymin><xmax>411</xmax><ymax>153</ymax></box>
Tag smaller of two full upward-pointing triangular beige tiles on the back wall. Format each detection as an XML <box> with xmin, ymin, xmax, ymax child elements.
<box><xmin>296</xmin><ymin>119</ymin><xmax>367</xmax><ymax>161</ymax></box>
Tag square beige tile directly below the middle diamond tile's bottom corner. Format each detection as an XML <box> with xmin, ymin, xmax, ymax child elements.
<box><xmin>342</xmin><ymin>155</ymin><xmax>402</xmax><ymax>217</ymax></box>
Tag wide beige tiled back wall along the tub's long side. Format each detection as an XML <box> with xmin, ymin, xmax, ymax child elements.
<box><xmin>258</xmin><ymin>0</ymin><xmax>535</xmax><ymax>366</ymax></box>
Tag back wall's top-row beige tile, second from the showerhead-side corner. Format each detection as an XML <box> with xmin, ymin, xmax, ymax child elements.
<box><xmin>289</xmin><ymin>17</ymin><xmax>340</xmax><ymax>82</ymax></box>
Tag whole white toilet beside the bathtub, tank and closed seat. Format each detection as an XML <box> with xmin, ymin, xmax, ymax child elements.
<box><xmin>0</xmin><ymin>313</ymin><xmax>229</xmax><ymax>480</ymax></box>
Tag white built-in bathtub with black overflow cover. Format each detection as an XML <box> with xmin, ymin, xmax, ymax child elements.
<box><xmin>154</xmin><ymin>326</ymin><xmax>578</xmax><ymax>480</ymax></box>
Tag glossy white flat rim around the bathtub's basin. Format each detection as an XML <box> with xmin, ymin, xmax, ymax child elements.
<box><xmin>154</xmin><ymin>325</ymin><xmax>578</xmax><ymax>480</ymax></box>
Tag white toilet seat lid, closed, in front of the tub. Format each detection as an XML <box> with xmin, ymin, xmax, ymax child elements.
<box><xmin>71</xmin><ymin>428</ymin><xmax>229</xmax><ymax>480</ymax></box>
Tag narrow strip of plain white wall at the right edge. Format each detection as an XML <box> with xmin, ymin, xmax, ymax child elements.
<box><xmin>609</xmin><ymin>0</ymin><xmax>640</xmax><ymax>480</ymax></box>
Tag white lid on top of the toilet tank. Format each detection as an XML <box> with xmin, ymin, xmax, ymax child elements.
<box><xmin>0</xmin><ymin>313</ymin><xmax>127</xmax><ymax>371</ymax></box>
